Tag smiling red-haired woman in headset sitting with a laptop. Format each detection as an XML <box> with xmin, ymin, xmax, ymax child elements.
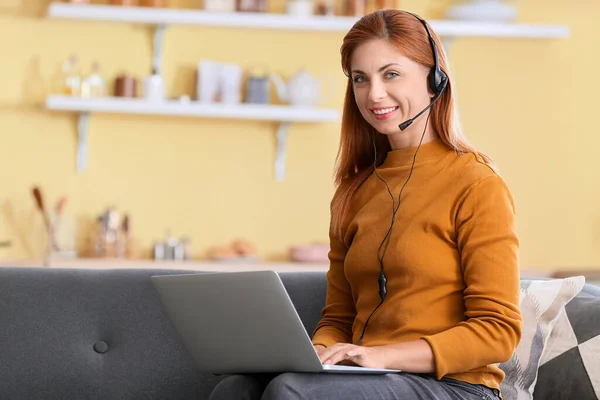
<box><xmin>211</xmin><ymin>10</ymin><xmax>522</xmax><ymax>400</ymax></box>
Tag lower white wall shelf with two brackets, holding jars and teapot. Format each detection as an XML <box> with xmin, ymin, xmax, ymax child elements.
<box><xmin>46</xmin><ymin>96</ymin><xmax>339</xmax><ymax>181</ymax></box>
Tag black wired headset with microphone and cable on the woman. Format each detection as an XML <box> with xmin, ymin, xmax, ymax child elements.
<box><xmin>356</xmin><ymin>11</ymin><xmax>448</xmax><ymax>344</ymax></box>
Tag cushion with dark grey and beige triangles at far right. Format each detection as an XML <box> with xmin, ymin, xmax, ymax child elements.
<box><xmin>534</xmin><ymin>293</ymin><xmax>600</xmax><ymax>400</ymax></box>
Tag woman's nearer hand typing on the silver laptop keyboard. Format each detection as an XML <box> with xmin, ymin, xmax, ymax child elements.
<box><xmin>315</xmin><ymin>343</ymin><xmax>386</xmax><ymax>368</ymax></box>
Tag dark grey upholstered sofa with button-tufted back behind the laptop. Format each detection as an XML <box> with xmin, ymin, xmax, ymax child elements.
<box><xmin>0</xmin><ymin>267</ymin><xmax>600</xmax><ymax>400</ymax></box>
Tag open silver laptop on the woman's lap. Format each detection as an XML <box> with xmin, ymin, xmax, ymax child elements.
<box><xmin>150</xmin><ymin>271</ymin><xmax>400</xmax><ymax>375</ymax></box>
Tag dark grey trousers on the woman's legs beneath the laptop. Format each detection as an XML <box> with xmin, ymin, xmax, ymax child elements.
<box><xmin>210</xmin><ymin>372</ymin><xmax>499</xmax><ymax>400</ymax></box>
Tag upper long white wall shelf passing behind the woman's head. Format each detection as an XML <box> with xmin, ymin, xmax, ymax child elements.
<box><xmin>48</xmin><ymin>3</ymin><xmax>569</xmax><ymax>39</ymax></box>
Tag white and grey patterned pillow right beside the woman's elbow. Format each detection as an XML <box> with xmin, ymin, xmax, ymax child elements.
<box><xmin>499</xmin><ymin>276</ymin><xmax>585</xmax><ymax>400</ymax></box>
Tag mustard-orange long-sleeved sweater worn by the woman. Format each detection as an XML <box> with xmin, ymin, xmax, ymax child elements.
<box><xmin>313</xmin><ymin>139</ymin><xmax>522</xmax><ymax>389</ymax></box>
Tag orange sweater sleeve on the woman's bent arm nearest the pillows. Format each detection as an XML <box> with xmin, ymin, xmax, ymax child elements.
<box><xmin>423</xmin><ymin>174</ymin><xmax>522</xmax><ymax>379</ymax></box>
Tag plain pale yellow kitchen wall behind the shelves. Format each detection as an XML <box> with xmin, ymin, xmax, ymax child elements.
<box><xmin>0</xmin><ymin>0</ymin><xmax>600</xmax><ymax>268</ymax></box>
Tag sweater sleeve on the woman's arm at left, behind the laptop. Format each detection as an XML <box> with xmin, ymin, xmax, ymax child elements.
<box><xmin>312</xmin><ymin>219</ymin><xmax>356</xmax><ymax>347</ymax></box>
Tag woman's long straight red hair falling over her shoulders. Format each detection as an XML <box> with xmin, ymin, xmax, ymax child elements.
<box><xmin>331</xmin><ymin>9</ymin><xmax>493</xmax><ymax>238</ymax></box>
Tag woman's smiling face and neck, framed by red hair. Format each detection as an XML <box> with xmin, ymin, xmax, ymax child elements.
<box><xmin>351</xmin><ymin>39</ymin><xmax>437</xmax><ymax>149</ymax></box>
